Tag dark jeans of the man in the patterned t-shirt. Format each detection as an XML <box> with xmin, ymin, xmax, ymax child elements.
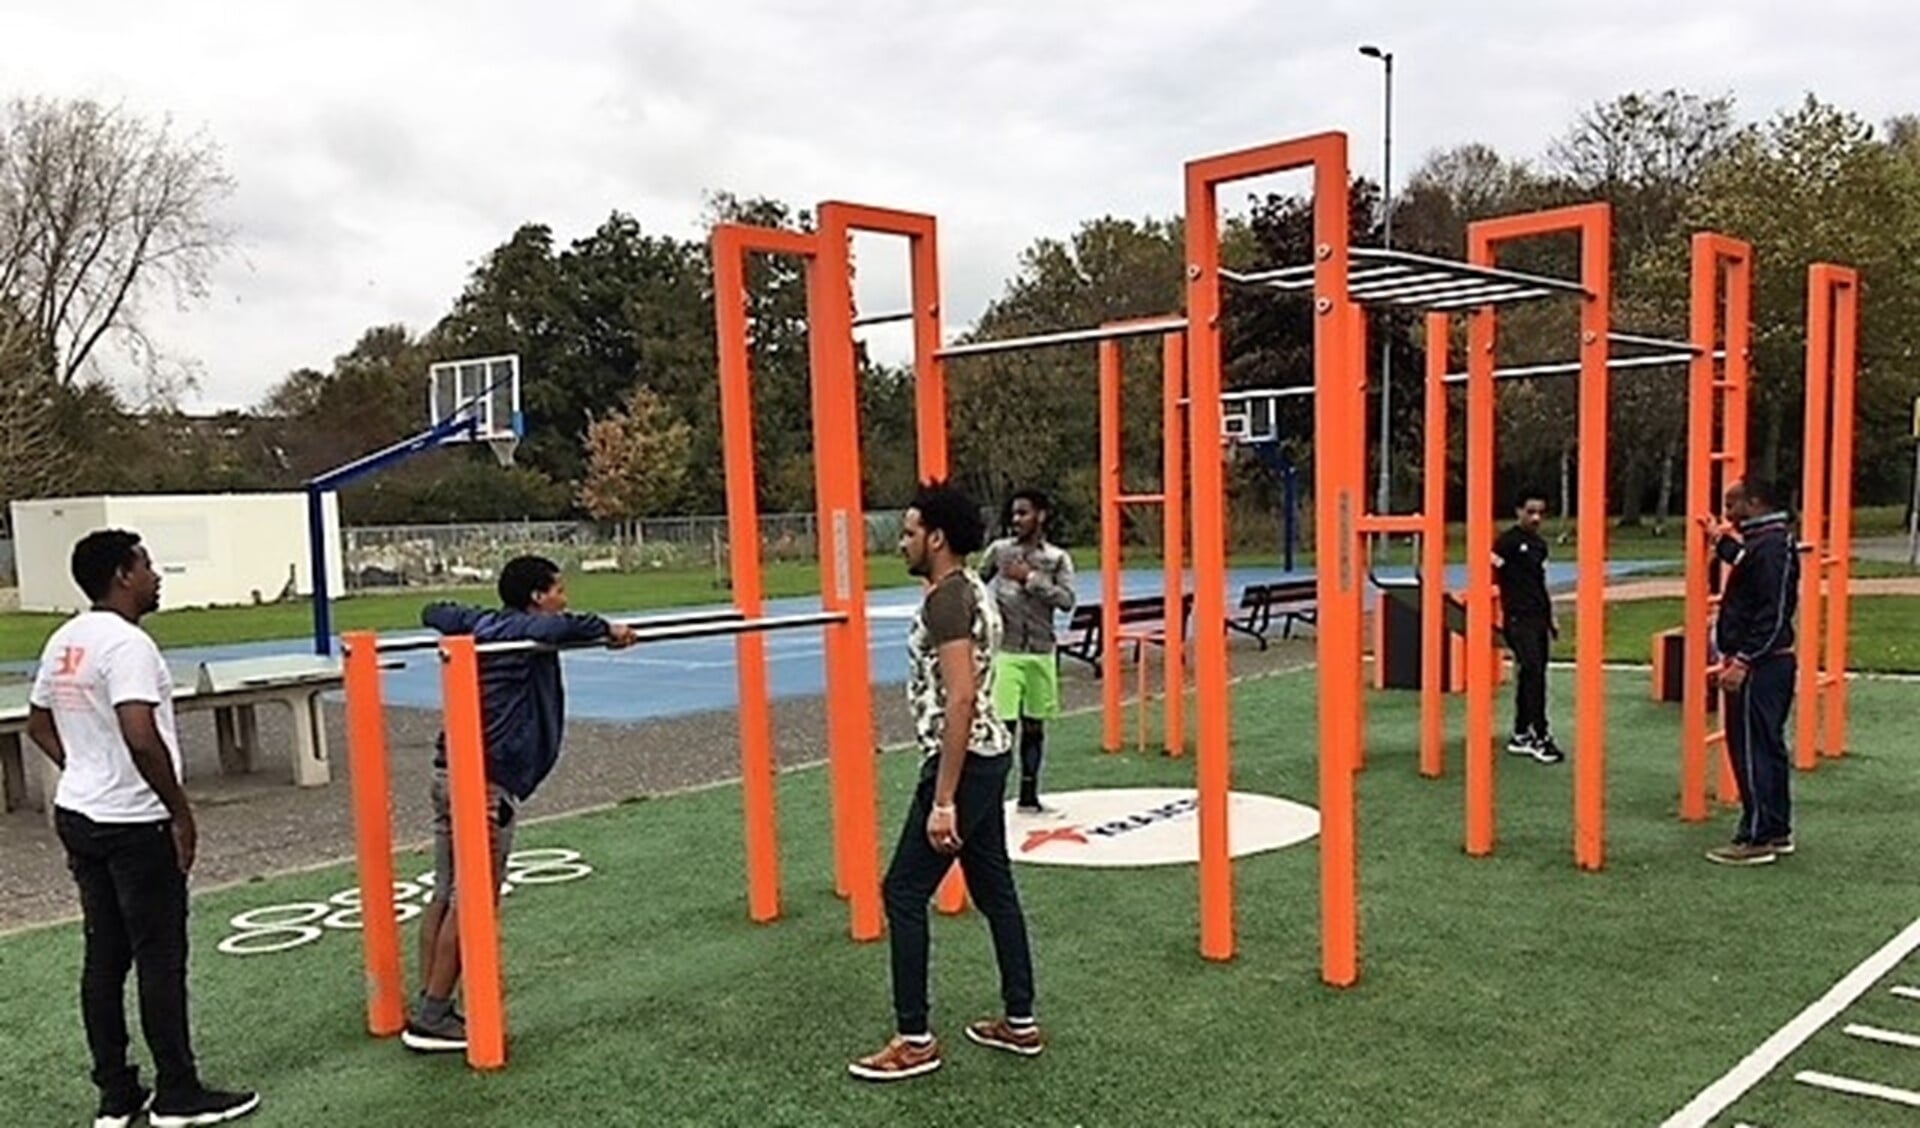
<box><xmin>883</xmin><ymin>756</ymin><xmax>1033</xmax><ymax>1034</ymax></box>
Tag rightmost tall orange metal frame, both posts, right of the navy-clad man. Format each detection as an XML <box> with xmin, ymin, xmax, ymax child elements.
<box><xmin>1793</xmin><ymin>263</ymin><xmax>1860</xmax><ymax>771</ymax></box>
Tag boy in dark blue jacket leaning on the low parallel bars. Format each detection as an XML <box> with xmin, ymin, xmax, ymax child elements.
<box><xmin>401</xmin><ymin>556</ymin><xmax>634</xmax><ymax>1053</ymax></box>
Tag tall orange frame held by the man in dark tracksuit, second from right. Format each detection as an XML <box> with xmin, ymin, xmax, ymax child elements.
<box><xmin>1680</xmin><ymin>232</ymin><xmax>1753</xmax><ymax>821</ymax></box>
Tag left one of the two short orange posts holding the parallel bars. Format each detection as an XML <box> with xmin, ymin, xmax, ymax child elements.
<box><xmin>342</xmin><ymin>631</ymin><xmax>407</xmax><ymax>1038</ymax></box>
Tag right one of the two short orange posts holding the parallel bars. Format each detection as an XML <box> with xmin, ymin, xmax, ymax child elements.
<box><xmin>440</xmin><ymin>635</ymin><xmax>507</xmax><ymax>1069</ymax></box>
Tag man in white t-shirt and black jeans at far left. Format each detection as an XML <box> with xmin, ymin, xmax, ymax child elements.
<box><xmin>27</xmin><ymin>529</ymin><xmax>259</xmax><ymax>1128</ymax></box>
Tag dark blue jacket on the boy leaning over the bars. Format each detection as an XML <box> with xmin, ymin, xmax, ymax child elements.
<box><xmin>420</xmin><ymin>602</ymin><xmax>609</xmax><ymax>800</ymax></box>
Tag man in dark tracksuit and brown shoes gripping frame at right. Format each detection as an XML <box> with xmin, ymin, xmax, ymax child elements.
<box><xmin>1707</xmin><ymin>480</ymin><xmax>1799</xmax><ymax>865</ymax></box>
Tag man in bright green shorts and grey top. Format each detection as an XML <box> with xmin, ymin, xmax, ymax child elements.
<box><xmin>979</xmin><ymin>489</ymin><xmax>1073</xmax><ymax>815</ymax></box>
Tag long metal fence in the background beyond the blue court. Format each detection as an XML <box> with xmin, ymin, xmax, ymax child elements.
<box><xmin>342</xmin><ymin>512</ymin><xmax>900</xmax><ymax>591</ymax></box>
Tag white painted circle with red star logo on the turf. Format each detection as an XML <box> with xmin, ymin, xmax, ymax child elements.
<box><xmin>1006</xmin><ymin>787</ymin><xmax>1319</xmax><ymax>869</ymax></box>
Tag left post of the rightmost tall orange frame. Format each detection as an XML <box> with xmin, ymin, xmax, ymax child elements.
<box><xmin>1793</xmin><ymin>265</ymin><xmax>1834</xmax><ymax>771</ymax></box>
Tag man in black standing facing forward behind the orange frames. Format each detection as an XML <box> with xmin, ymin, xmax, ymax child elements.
<box><xmin>1494</xmin><ymin>489</ymin><xmax>1567</xmax><ymax>764</ymax></box>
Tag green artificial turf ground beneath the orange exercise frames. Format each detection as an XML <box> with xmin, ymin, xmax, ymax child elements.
<box><xmin>0</xmin><ymin>673</ymin><xmax>1920</xmax><ymax>1128</ymax></box>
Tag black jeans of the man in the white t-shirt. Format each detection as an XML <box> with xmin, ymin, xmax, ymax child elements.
<box><xmin>54</xmin><ymin>808</ymin><xmax>200</xmax><ymax>1097</ymax></box>
